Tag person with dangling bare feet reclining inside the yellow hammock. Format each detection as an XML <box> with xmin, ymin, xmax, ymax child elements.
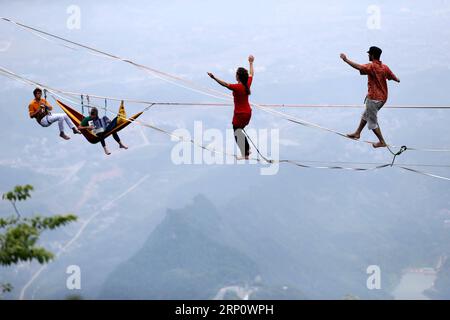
<box><xmin>78</xmin><ymin>108</ymin><xmax>128</xmax><ymax>155</ymax></box>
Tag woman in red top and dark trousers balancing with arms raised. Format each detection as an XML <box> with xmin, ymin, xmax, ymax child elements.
<box><xmin>208</xmin><ymin>55</ymin><xmax>255</xmax><ymax>160</ymax></box>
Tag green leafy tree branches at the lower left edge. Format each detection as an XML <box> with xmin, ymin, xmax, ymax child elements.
<box><xmin>0</xmin><ymin>185</ymin><xmax>77</xmax><ymax>293</ymax></box>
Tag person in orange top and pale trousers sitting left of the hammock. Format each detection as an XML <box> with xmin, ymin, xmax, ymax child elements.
<box><xmin>28</xmin><ymin>88</ymin><xmax>80</xmax><ymax>140</ymax></box>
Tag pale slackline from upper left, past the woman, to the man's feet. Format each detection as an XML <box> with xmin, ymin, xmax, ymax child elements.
<box><xmin>1</xmin><ymin>17</ymin><xmax>450</xmax><ymax>155</ymax></box>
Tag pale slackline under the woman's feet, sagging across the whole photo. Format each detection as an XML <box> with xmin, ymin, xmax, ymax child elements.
<box><xmin>0</xmin><ymin>68</ymin><xmax>450</xmax><ymax>181</ymax></box>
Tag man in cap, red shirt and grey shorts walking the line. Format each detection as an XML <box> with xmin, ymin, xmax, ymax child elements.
<box><xmin>341</xmin><ymin>47</ymin><xmax>400</xmax><ymax>148</ymax></box>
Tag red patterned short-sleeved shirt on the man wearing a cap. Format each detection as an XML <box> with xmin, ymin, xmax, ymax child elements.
<box><xmin>360</xmin><ymin>61</ymin><xmax>395</xmax><ymax>101</ymax></box>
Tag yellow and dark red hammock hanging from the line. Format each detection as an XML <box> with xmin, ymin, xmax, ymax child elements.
<box><xmin>56</xmin><ymin>100</ymin><xmax>143</xmax><ymax>144</ymax></box>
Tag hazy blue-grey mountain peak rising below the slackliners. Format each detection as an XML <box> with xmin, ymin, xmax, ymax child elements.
<box><xmin>100</xmin><ymin>197</ymin><xmax>276</xmax><ymax>299</ymax></box>
